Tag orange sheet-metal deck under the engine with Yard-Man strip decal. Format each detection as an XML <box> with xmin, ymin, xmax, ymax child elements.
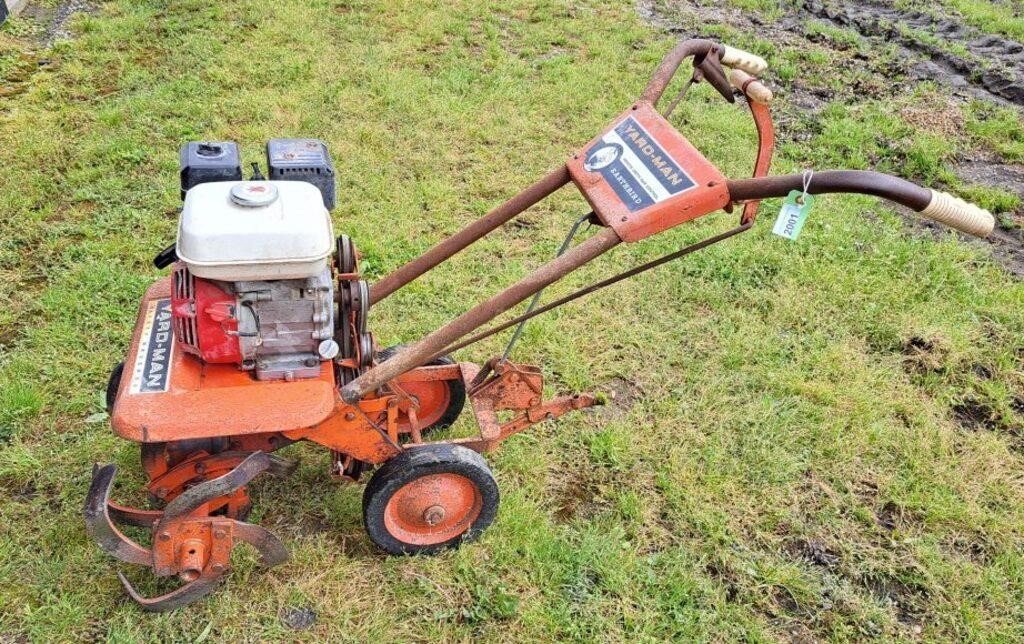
<box><xmin>111</xmin><ymin>277</ymin><xmax>335</xmax><ymax>442</ymax></box>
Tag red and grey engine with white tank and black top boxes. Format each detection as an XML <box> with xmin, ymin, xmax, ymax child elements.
<box><xmin>171</xmin><ymin>139</ymin><xmax>340</xmax><ymax>380</ymax></box>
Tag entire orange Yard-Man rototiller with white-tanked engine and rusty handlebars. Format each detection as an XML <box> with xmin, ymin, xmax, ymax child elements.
<box><xmin>85</xmin><ymin>40</ymin><xmax>993</xmax><ymax>610</ymax></box>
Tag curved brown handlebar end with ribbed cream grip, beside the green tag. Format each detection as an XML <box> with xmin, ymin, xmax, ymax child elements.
<box><xmin>728</xmin><ymin>170</ymin><xmax>995</xmax><ymax>238</ymax></box>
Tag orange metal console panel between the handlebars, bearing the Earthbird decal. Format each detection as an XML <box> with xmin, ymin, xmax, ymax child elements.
<box><xmin>567</xmin><ymin>101</ymin><xmax>729</xmax><ymax>242</ymax></box>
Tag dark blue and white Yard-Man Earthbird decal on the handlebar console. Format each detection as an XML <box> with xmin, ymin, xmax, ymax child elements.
<box><xmin>583</xmin><ymin>117</ymin><xmax>696</xmax><ymax>212</ymax></box>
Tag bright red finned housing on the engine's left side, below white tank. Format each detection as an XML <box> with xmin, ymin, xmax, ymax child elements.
<box><xmin>171</xmin><ymin>263</ymin><xmax>242</xmax><ymax>363</ymax></box>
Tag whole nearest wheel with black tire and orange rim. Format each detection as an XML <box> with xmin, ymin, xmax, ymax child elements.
<box><xmin>362</xmin><ymin>444</ymin><xmax>499</xmax><ymax>555</ymax></box>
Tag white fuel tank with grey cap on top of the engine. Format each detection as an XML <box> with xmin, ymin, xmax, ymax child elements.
<box><xmin>177</xmin><ymin>181</ymin><xmax>334</xmax><ymax>282</ymax></box>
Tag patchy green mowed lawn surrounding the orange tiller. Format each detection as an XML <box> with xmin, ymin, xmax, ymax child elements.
<box><xmin>0</xmin><ymin>0</ymin><xmax>1024</xmax><ymax>642</ymax></box>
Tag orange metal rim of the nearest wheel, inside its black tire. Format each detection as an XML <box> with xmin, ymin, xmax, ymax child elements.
<box><xmin>384</xmin><ymin>474</ymin><xmax>483</xmax><ymax>546</ymax></box>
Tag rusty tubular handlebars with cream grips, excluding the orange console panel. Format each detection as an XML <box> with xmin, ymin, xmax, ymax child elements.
<box><xmin>340</xmin><ymin>40</ymin><xmax>993</xmax><ymax>403</ymax></box>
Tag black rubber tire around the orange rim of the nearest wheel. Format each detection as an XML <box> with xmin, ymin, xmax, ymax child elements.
<box><xmin>362</xmin><ymin>443</ymin><xmax>501</xmax><ymax>555</ymax></box>
